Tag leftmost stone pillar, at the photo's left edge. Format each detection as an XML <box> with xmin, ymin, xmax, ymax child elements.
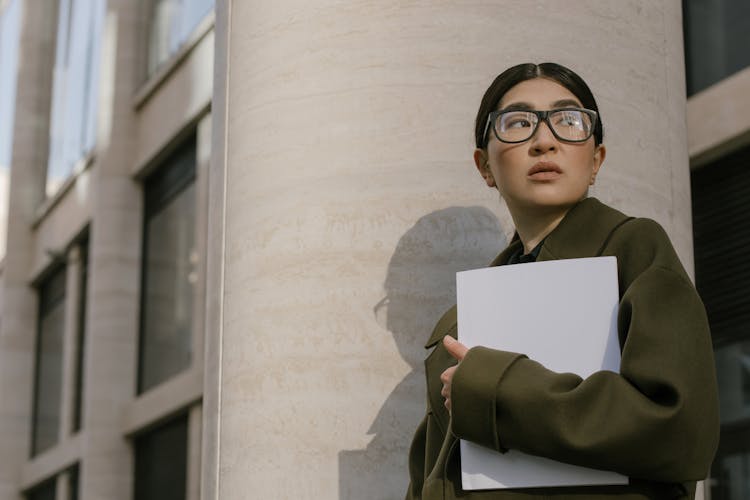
<box><xmin>0</xmin><ymin>2</ymin><xmax>57</xmax><ymax>500</ymax></box>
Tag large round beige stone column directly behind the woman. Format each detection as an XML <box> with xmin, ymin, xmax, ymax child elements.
<box><xmin>204</xmin><ymin>0</ymin><xmax>692</xmax><ymax>499</ymax></box>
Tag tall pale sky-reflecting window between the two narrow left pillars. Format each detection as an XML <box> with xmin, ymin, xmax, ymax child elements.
<box><xmin>47</xmin><ymin>0</ymin><xmax>106</xmax><ymax>196</ymax></box>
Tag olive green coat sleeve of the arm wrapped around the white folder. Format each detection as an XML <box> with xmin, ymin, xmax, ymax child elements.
<box><xmin>451</xmin><ymin>219</ymin><xmax>719</xmax><ymax>482</ymax></box>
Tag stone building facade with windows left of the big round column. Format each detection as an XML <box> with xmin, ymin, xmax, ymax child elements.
<box><xmin>0</xmin><ymin>0</ymin><xmax>214</xmax><ymax>500</ymax></box>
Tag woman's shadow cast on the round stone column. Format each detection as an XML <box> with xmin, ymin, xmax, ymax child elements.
<box><xmin>339</xmin><ymin>207</ymin><xmax>507</xmax><ymax>500</ymax></box>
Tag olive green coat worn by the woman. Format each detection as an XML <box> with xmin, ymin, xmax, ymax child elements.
<box><xmin>406</xmin><ymin>198</ymin><xmax>719</xmax><ymax>500</ymax></box>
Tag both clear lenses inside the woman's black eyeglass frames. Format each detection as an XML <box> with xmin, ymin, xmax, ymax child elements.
<box><xmin>495</xmin><ymin>109</ymin><xmax>593</xmax><ymax>142</ymax></box>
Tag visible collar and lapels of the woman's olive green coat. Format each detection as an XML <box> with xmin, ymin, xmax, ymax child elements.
<box><xmin>425</xmin><ymin>198</ymin><xmax>632</xmax><ymax>348</ymax></box>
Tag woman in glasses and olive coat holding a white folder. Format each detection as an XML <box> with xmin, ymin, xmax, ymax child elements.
<box><xmin>407</xmin><ymin>63</ymin><xmax>719</xmax><ymax>500</ymax></box>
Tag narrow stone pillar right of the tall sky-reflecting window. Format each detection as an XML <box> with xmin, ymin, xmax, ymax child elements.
<box><xmin>79</xmin><ymin>0</ymin><xmax>142</xmax><ymax>500</ymax></box>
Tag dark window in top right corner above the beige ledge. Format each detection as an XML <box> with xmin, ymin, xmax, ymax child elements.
<box><xmin>682</xmin><ymin>0</ymin><xmax>750</xmax><ymax>95</ymax></box>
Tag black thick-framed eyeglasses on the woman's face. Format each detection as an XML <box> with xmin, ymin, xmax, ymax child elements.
<box><xmin>482</xmin><ymin>108</ymin><xmax>597</xmax><ymax>145</ymax></box>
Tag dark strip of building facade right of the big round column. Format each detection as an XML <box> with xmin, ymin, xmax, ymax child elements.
<box><xmin>683</xmin><ymin>0</ymin><xmax>750</xmax><ymax>500</ymax></box>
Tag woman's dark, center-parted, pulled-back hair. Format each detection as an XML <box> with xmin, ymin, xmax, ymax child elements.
<box><xmin>474</xmin><ymin>63</ymin><xmax>604</xmax><ymax>149</ymax></box>
